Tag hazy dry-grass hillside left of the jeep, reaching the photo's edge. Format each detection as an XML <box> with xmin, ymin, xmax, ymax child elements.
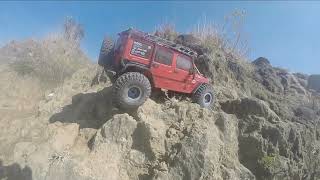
<box><xmin>0</xmin><ymin>17</ymin><xmax>90</xmax><ymax>112</ymax></box>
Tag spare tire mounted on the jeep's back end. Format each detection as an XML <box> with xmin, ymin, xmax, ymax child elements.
<box><xmin>98</xmin><ymin>37</ymin><xmax>114</xmax><ymax>69</ymax></box>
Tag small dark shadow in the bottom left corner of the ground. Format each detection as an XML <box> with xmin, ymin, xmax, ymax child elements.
<box><xmin>0</xmin><ymin>160</ymin><xmax>32</xmax><ymax>180</ymax></box>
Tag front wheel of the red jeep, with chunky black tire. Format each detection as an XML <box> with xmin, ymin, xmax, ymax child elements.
<box><xmin>192</xmin><ymin>84</ymin><xmax>215</xmax><ymax>109</ymax></box>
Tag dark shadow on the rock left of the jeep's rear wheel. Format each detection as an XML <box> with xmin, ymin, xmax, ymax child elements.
<box><xmin>49</xmin><ymin>87</ymin><xmax>118</xmax><ymax>129</ymax></box>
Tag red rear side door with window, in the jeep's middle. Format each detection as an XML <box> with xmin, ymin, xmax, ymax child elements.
<box><xmin>151</xmin><ymin>46</ymin><xmax>174</xmax><ymax>90</ymax></box>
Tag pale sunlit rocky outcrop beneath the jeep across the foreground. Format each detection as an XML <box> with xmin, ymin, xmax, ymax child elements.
<box><xmin>8</xmin><ymin>95</ymin><xmax>254</xmax><ymax>180</ymax></box>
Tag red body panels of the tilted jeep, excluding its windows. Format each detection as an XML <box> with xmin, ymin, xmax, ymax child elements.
<box><xmin>115</xmin><ymin>29</ymin><xmax>209</xmax><ymax>93</ymax></box>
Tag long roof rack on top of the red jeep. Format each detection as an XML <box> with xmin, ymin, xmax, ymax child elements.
<box><xmin>124</xmin><ymin>28</ymin><xmax>198</xmax><ymax>57</ymax></box>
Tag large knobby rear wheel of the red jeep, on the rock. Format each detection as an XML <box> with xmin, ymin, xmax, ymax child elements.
<box><xmin>112</xmin><ymin>72</ymin><xmax>151</xmax><ymax>110</ymax></box>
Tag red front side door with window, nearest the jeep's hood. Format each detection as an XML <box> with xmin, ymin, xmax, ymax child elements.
<box><xmin>173</xmin><ymin>54</ymin><xmax>196</xmax><ymax>93</ymax></box>
